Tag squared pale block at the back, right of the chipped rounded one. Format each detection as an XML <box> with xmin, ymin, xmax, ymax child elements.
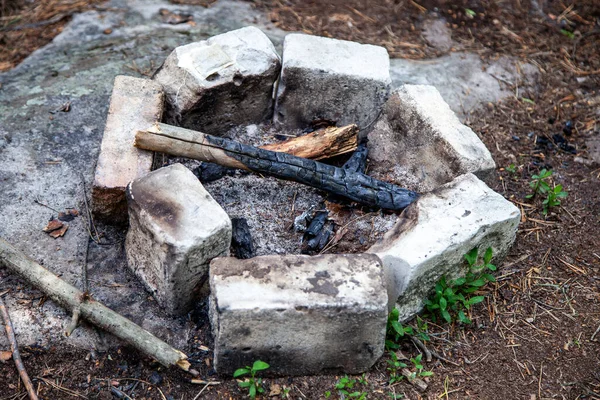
<box><xmin>274</xmin><ymin>34</ymin><xmax>391</xmax><ymax>129</ymax></box>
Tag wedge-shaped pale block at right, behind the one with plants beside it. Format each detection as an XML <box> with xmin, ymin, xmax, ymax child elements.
<box><xmin>368</xmin><ymin>85</ymin><xmax>496</xmax><ymax>193</ymax></box>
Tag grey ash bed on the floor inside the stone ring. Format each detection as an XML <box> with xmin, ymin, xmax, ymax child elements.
<box><xmin>168</xmin><ymin>124</ymin><xmax>397</xmax><ymax>256</ymax></box>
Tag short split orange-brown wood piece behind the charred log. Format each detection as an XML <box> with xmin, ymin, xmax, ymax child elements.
<box><xmin>260</xmin><ymin>124</ymin><xmax>358</xmax><ymax>160</ymax></box>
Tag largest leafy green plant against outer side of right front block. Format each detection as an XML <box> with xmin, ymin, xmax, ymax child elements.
<box><xmin>425</xmin><ymin>247</ymin><xmax>496</xmax><ymax>324</ymax></box>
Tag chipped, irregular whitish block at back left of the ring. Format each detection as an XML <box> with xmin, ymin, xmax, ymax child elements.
<box><xmin>153</xmin><ymin>27</ymin><xmax>281</xmax><ymax>134</ymax></box>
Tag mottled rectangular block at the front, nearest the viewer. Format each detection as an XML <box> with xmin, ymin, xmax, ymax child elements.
<box><xmin>210</xmin><ymin>254</ymin><xmax>387</xmax><ymax>376</ymax></box>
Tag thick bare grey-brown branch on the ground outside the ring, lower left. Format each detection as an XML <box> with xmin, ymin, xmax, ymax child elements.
<box><xmin>0</xmin><ymin>238</ymin><xmax>190</xmax><ymax>371</ymax></box>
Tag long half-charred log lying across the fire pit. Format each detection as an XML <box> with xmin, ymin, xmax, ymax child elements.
<box><xmin>134</xmin><ymin>123</ymin><xmax>418</xmax><ymax>211</ymax></box>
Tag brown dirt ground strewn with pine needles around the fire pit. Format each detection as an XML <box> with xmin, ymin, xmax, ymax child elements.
<box><xmin>0</xmin><ymin>0</ymin><xmax>600</xmax><ymax>400</ymax></box>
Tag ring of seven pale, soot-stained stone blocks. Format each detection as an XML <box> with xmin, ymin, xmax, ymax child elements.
<box><xmin>93</xmin><ymin>28</ymin><xmax>520</xmax><ymax>375</ymax></box>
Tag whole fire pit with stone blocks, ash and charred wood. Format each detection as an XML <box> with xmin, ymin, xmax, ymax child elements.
<box><xmin>93</xmin><ymin>27</ymin><xmax>520</xmax><ymax>375</ymax></box>
